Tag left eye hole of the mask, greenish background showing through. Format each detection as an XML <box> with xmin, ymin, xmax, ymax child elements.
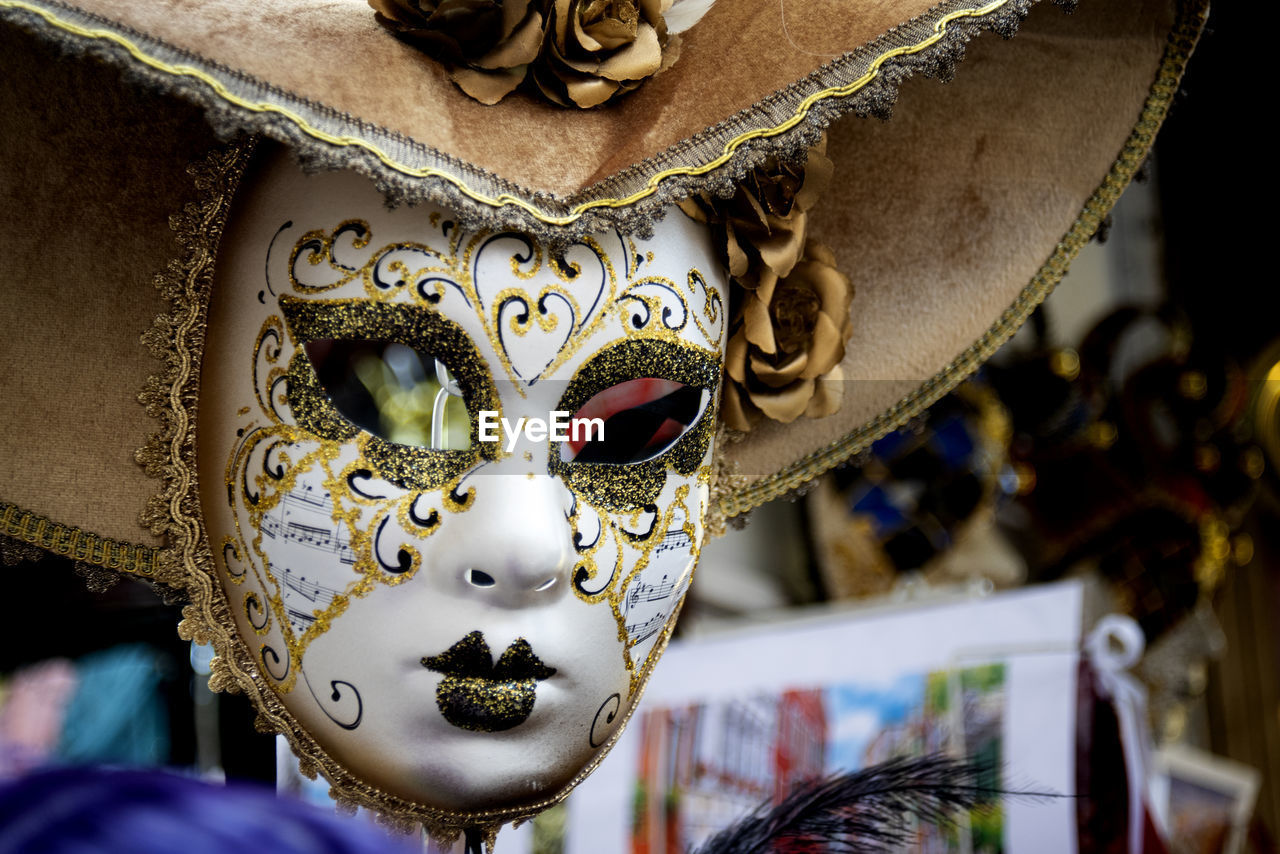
<box><xmin>305</xmin><ymin>338</ymin><xmax>471</xmax><ymax>451</ymax></box>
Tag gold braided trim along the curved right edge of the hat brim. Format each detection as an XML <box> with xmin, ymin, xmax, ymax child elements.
<box><xmin>712</xmin><ymin>0</ymin><xmax>1208</xmax><ymax>525</ymax></box>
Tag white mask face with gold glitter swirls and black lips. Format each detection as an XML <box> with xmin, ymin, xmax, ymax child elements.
<box><xmin>198</xmin><ymin>150</ymin><xmax>727</xmax><ymax>813</ymax></box>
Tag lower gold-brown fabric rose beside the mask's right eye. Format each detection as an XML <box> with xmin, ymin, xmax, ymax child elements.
<box><xmin>721</xmin><ymin>239</ymin><xmax>854</xmax><ymax>430</ymax></box>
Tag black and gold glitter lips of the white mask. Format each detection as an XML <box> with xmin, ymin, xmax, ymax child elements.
<box><xmin>422</xmin><ymin>631</ymin><xmax>556</xmax><ymax>732</ymax></box>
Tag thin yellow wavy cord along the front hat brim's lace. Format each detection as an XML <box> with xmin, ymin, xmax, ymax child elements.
<box><xmin>0</xmin><ymin>0</ymin><xmax>1010</xmax><ymax>225</ymax></box>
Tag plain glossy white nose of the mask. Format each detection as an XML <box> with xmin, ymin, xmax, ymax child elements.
<box><xmin>440</xmin><ymin>474</ymin><xmax>575</xmax><ymax>608</ymax></box>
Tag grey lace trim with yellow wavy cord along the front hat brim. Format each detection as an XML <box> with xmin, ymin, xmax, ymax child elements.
<box><xmin>0</xmin><ymin>0</ymin><xmax>1039</xmax><ymax>239</ymax></box>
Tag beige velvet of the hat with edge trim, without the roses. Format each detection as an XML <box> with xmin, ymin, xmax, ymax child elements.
<box><xmin>0</xmin><ymin>0</ymin><xmax>1203</xmax><ymax>576</ymax></box>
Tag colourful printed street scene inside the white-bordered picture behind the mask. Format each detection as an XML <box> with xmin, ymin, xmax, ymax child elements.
<box><xmin>630</xmin><ymin>663</ymin><xmax>1005</xmax><ymax>854</ymax></box>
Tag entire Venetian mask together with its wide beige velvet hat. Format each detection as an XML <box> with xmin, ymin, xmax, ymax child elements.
<box><xmin>0</xmin><ymin>0</ymin><xmax>1204</xmax><ymax>849</ymax></box>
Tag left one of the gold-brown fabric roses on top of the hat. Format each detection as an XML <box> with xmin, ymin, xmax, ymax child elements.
<box><xmin>369</xmin><ymin>0</ymin><xmax>545</xmax><ymax>104</ymax></box>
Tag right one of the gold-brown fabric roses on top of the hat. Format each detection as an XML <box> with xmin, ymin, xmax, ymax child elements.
<box><xmin>534</xmin><ymin>0</ymin><xmax>678</xmax><ymax>109</ymax></box>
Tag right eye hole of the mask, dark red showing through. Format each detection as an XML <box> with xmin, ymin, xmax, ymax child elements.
<box><xmin>562</xmin><ymin>376</ymin><xmax>708</xmax><ymax>465</ymax></box>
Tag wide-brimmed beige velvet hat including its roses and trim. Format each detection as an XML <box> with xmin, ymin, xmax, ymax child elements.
<box><xmin>0</xmin><ymin>0</ymin><xmax>1206</xmax><ymax>834</ymax></box>
